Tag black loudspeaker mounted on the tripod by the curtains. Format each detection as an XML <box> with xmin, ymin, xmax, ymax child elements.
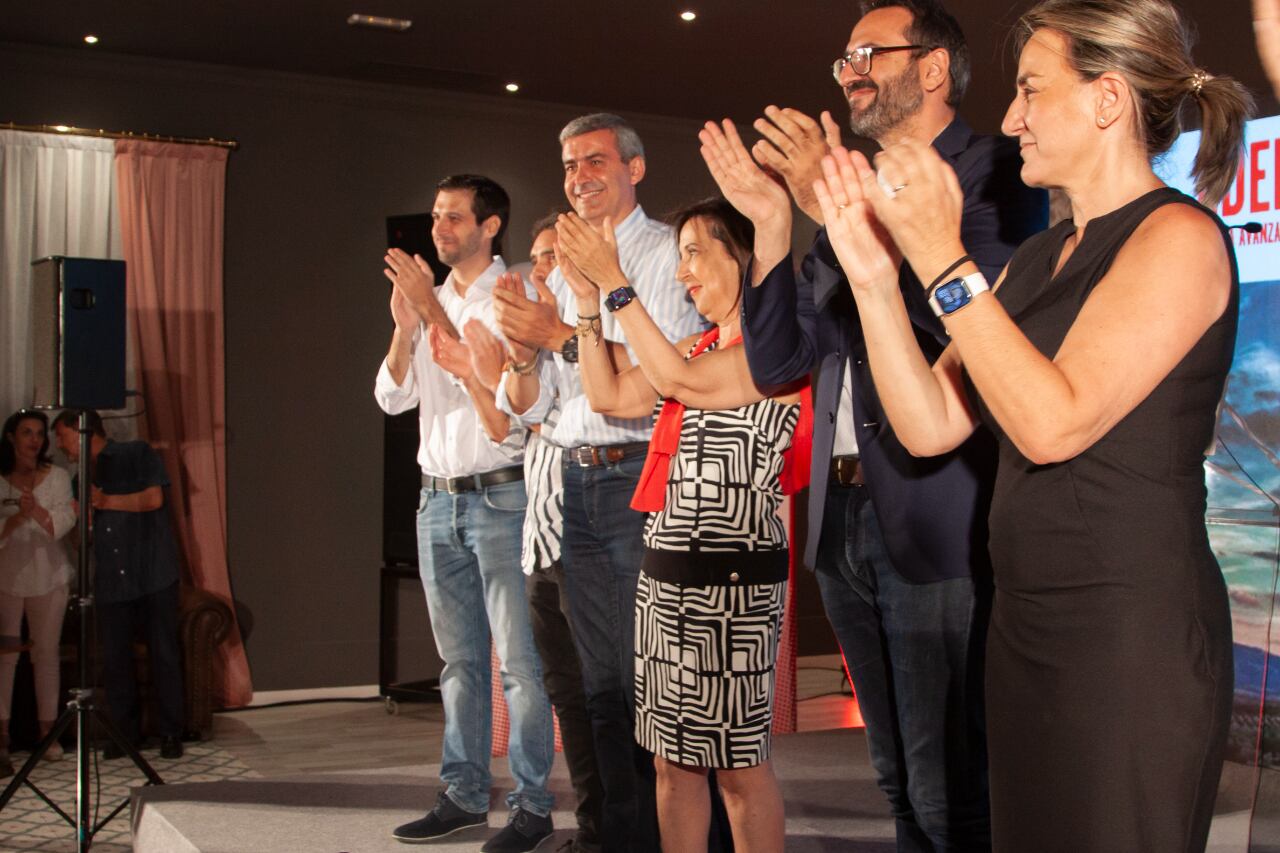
<box><xmin>31</xmin><ymin>256</ymin><xmax>124</xmax><ymax>409</ymax></box>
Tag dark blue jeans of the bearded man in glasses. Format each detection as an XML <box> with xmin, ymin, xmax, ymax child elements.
<box><xmin>817</xmin><ymin>485</ymin><xmax>991</xmax><ymax>852</ymax></box>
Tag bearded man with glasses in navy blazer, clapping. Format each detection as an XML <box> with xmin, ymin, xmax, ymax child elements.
<box><xmin>742</xmin><ymin>0</ymin><xmax>1048</xmax><ymax>850</ymax></box>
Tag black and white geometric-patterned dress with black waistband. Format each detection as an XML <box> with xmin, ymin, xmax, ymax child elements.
<box><xmin>636</xmin><ymin>368</ymin><xmax>800</xmax><ymax>767</ymax></box>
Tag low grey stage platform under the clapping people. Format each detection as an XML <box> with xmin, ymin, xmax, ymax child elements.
<box><xmin>133</xmin><ymin>729</ymin><xmax>1248</xmax><ymax>853</ymax></box>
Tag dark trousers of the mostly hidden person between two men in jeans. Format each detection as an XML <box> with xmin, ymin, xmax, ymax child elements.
<box><xmin>525</xmin><ymin>561</ymin><xmax>604</xmax><ymax>849</ymax></box>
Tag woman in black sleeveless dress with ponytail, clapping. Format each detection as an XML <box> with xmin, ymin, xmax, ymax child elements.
<box><xmin>818</xmin><ymin>0</ymin><xmax>1248</xmax><ymax>853</ymax></box>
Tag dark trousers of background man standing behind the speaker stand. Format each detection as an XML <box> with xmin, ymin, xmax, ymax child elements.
<box><xmin>96</xmin><ymin>581</ymin><xmax>183</xmax><ymax>743</ymax></box>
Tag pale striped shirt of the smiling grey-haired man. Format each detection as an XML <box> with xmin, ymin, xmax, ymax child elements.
<box><xmin>497</xmin><ymin>205</ymin><xmax>705</xmax><ymax>447</ymax></box>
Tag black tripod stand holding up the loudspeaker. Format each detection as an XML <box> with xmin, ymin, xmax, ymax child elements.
<box><xmin>0</xmin><ymin>411</ymin><xmax>164</xmax><ymax>853</ymax></box>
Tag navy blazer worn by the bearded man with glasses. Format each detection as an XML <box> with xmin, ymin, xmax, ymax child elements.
<box><xmin>742</xmin><ymin>117</ymin><xmax>1048</xmax><ymax>583</ymax></box>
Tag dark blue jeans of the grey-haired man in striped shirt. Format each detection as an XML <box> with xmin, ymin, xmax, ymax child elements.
<box><xmin>561</xmin><ymin>453</ymin><xmax>658</xmax><ymax>852</ymax></box>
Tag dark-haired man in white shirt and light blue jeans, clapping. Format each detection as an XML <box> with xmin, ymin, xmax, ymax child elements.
<box><xmin>374</xmin><ymin>175</ymin><xmax>554</xmax><ymax>853</ymax></box>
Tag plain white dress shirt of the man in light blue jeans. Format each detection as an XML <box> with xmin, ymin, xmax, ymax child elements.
<box><xmin>374</xmin><ymin>256</ymin><xmax>524</xmax><ymax>476</ymax></box>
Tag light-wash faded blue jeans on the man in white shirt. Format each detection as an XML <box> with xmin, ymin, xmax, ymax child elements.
<box><xmin>417</xmin><ymin>482</ymin><xmax>556</xmax><ymax>816</ymax></box>
